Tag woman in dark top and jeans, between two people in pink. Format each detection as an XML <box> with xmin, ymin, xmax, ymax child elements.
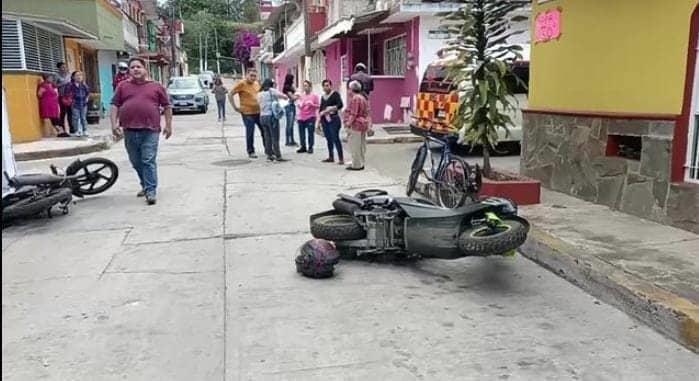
<box><xmin>318</xmin><ymin>79</ymin><xmax>345</xmax><ymax>165</ymax></box>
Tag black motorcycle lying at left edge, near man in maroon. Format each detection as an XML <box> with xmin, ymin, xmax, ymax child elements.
<box><xmin>2</xmin><ymin>157</ymin><xmax>119</xmax><ymax>222</ymax></box>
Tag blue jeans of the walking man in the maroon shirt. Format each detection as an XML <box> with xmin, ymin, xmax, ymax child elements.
<box><xmin>124</xmin><ymin>129</ymin><xmax>159</xmax><ymax>197</ymax></box>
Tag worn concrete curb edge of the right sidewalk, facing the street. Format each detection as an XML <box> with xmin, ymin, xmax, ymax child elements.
<box><xmin>519</xmin><ymin>227</ymin><xmax>699</xmax><ymax>353</ymax></box>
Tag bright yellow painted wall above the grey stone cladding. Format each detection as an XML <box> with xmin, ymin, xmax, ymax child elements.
<box><xmin>529</xmin><ymin>0</ymin><xmax>699</xmax><ymax>115</ymax></box>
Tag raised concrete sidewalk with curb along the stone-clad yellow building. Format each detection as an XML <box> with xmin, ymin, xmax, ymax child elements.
<box><xmin>520</xmin><ymin>190</ymin><xmax>699</xmax><ymax>352</ymax></box>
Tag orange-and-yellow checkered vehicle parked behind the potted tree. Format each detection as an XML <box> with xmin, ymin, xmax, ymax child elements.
<box><xmin>410</xmin><ymin>56</ymin><xmax>529</xmax><ymax>151</ymax></box>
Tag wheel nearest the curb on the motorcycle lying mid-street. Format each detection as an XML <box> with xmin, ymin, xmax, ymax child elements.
<box><xmin>459</xmin><ymin>218</ymin><xmax>529</xmax><ymax>256</ymax></box>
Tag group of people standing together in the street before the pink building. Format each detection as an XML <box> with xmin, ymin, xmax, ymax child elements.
<box><xmin>228</xmin><ymin>64</ymin><xmax>373</xmax><ymax>171</ymax></box>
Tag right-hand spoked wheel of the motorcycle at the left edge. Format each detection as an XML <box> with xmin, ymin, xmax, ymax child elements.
<box><xmin>66</xmin><ymin>157</ymin><xmax>119</xmax><ymax>196</ymax></box>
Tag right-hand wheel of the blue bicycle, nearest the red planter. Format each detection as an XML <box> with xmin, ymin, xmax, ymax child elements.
<box><xmin>436</xmin><ymin>158</ymin><xmax>470</xmax><ymax>208</ymax></box>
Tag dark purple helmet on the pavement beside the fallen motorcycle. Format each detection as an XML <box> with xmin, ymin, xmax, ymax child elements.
<box><xmin>296</xmin><ymin>239</ymin><xmax>340</xmax><ymax>278</ymax></box>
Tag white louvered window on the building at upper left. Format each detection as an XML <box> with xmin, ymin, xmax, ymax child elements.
<box><xmin>2</xmin><ymin>19</ymin><xmax>64</xmax><ymax>72</ymax></box>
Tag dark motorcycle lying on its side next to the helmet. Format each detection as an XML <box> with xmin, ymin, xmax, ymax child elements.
<box><xmin>310</xmin><ymin>190</ymin><xmax>529</xmax><ymax>259</ymax></box>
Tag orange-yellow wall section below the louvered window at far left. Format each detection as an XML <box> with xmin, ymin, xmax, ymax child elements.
<box><xmin>2</xmin><ymin>73</ymin><xmax>42</xmax><ymax>143</ymax></box>
